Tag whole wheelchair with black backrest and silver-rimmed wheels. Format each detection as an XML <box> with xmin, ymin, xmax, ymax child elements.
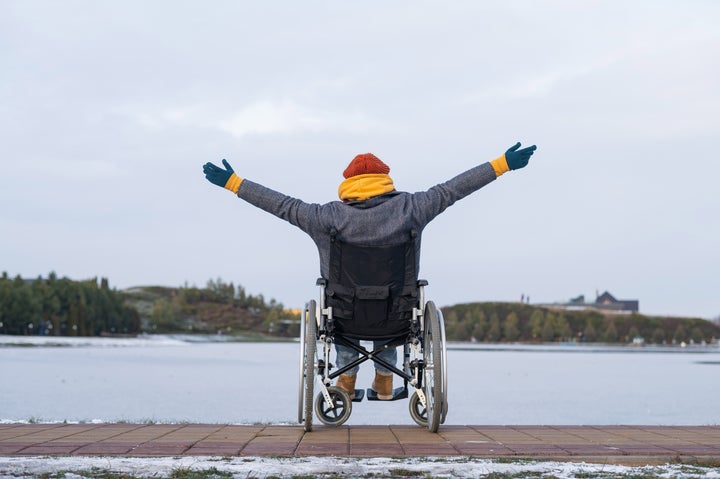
<box><xmin>298</xmin><ymin>232</ymin><xmax>448</xmax><ymax>432</ymax></box>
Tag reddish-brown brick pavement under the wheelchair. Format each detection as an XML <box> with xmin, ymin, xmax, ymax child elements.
<box><xmin>0</xmin><ymin>424</ymin><xmax>720</xmax><ymax>464</ymax></box>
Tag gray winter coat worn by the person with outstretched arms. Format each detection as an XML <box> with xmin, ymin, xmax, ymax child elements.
<box><xmin>238</xmin><ymin>163</ymin><xmax>496</xmax><ymax>278</ymax></box>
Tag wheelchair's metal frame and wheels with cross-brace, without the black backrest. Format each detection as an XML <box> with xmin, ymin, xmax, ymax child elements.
<box><xmin>298</xmin><ymin>278</ymin><xmax>448</xmax><ymax>432</ymax></box>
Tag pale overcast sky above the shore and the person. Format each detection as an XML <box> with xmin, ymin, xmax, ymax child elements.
<box><xmin>0</xmin><ymin>0</ymin><xmax>720</xmax><ymax>318</ymax></box>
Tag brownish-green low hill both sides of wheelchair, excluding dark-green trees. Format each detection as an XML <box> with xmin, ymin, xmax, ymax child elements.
<box><xmin>124</xmin><ymin>282</ymin><xmax>720</xmax><ymax>344</ymax></box>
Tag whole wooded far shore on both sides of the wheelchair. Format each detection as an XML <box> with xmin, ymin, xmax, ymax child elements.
<box><xmin>0</xmin><ymin>273</ymin><xmax>720</xmax><ymax>344</ymax></box>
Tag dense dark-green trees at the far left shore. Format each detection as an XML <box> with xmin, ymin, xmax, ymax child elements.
<box><xmin>0</xmin><ymin>272</ymin><xmax>140</xmax><ymax>336</ymax></box>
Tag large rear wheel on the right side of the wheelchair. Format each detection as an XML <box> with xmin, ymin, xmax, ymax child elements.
<box><xmin>423</xmin><ymin>301</ymin><xmax>445</xmax><ymax>432</ymax></box>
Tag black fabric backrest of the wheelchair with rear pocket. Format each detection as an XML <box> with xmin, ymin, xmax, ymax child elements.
<box><xmin>325</xmin><ymin>231</ymin><xmax>418</xmax><ymax>339</ymax></box>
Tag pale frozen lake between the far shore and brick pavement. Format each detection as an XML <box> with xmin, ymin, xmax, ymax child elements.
<box><xmin>0</xmin><ymin>336</ymin><xmax>720</xmax><ymax>425</ymax></box>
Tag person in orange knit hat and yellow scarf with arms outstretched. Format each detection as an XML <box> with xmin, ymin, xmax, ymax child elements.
<box><xmin>203</xmin><ymin>142</ymin><xmax>536</xmax><ymax>400</ymax></box>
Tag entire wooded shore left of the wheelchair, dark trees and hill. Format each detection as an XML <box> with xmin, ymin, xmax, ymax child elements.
<box><xmin>0</xmin><ymin>272</ymin><xmax>297</xmax><ymax>336</ymax></box>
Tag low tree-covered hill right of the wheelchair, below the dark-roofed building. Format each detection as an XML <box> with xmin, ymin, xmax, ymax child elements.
<box><xmin>442</xmin><ymin>303</ymin><xmax>720</xmax><ymax>344</ymax></box>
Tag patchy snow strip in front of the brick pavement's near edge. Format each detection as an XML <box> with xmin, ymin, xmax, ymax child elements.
<box><xmin>0</xmin><ymin>456</ymin><xmax>720</xmax><ymax>479</ymax></box>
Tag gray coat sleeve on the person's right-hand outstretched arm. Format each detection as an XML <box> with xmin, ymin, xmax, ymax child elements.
<box><xmin>412</xmin><ymin>162</ymin><xmax>497</xmax><ymax>226</ymax></box>
